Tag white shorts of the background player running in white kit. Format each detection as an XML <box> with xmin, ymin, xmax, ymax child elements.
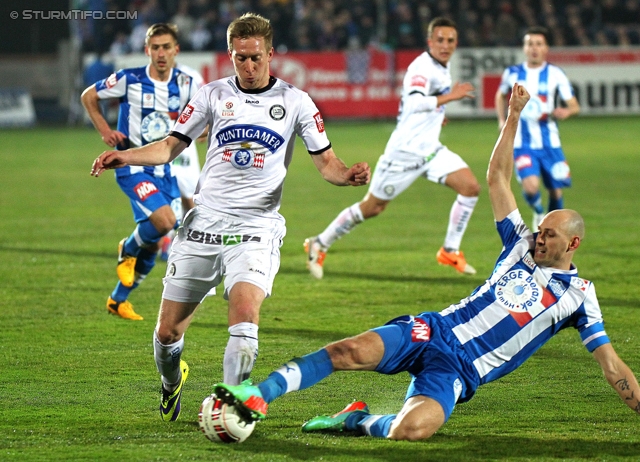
<box><xmin>369</xmin><ymin>146</ymin><xmax>468</xmax><ymax>200</ymax></box>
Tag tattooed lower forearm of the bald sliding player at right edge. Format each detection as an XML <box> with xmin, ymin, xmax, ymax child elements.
<box><xmin>593</xmin><ymin>343</ymin><xmax>640</xmax><ymax>414</ymax></box>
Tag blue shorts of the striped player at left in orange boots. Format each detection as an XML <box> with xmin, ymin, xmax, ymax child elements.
<box><xmin>116</xmin><ymin>173</ymin><xmax>182</xmax><ymax>224</ymax></box>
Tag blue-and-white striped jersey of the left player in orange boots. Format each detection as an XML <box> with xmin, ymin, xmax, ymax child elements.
<box><xmin>96</xmin><ymin>65</ymin><xmax>198</xmax><ymax>177</ymax></box>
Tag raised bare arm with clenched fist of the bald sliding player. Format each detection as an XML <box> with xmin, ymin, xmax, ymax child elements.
<box><xmin>487</xmin><ymin>83</ymin><xmax>529</xmax><ymax>221</ymax></box>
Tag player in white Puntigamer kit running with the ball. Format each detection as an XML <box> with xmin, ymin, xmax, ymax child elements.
<box><xmin>92</xmin><ymin>13</ymin><xmax>371</xmax><ymax>421</ymax></box>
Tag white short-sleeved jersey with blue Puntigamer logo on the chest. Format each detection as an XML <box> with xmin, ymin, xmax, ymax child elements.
<box><xmin>172</xmin><ymin>77</ymin><xmax>331</xmax><ymax>222</ymax></box>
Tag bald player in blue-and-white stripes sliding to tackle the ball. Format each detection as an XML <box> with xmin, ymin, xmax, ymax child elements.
<box><xmin>214</xmin><ymin>83</ymin><xmax>640</xmax><ymax>440</ymax></box>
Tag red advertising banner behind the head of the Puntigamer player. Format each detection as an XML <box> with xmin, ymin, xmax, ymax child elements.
<box><xmin>204</xmin><ymin>49</ymin><xmax>420</xmax><ymax>119</ymax></box>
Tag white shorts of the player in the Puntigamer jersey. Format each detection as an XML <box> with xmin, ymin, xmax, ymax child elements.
<box><xmin>162</xmin><ymin>206</ymin><xmax>286</xmax><ymax>303</ymax></box>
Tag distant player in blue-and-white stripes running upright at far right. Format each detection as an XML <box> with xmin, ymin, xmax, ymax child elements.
<box><xmin>495</xmin><ymin>26</ymin><xmax>580</xmax><ymax>231</ymax></box>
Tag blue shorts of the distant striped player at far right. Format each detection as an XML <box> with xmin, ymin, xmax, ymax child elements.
<box><xmin>513</xmin><ymin>148</ymin><xmax>571</xmax><ymax>189</ymax></box>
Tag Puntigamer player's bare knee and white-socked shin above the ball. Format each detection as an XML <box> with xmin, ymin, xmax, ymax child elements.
<box><xmin>223</xmin><ymin>282</ymin><xmax>265</xmax><ymax>385</ymax></box>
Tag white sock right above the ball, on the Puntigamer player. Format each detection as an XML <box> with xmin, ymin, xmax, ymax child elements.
<box><xmin>223</xmin><ymin>322</ymin><xmax>258</xmax><ymax>385</ymax></box>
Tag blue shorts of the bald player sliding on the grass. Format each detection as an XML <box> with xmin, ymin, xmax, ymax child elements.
<box><xmin>372</xmin><ymin>313</ymin><xmax>480</xmax><ymax>421</ymax></box>
